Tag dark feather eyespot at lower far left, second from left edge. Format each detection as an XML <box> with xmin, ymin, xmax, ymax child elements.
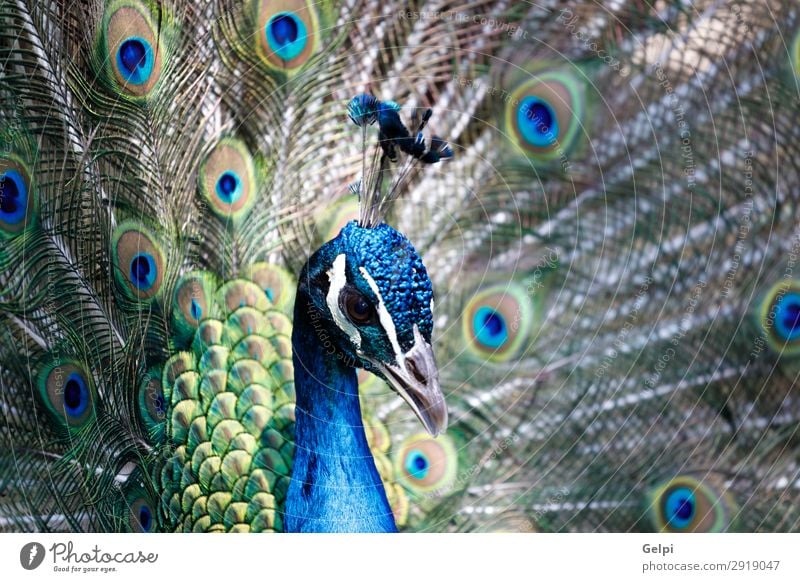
<box><xmin>37</xmin><ymin>360</ymin><xmax>97</xmax><ymax>429</ymax></box>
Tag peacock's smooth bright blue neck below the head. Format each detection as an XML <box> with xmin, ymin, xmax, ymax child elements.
<box><xmin>284</xmin><ymin>294</ymin><xmax>397</xmax><ymax>532</ymax></box>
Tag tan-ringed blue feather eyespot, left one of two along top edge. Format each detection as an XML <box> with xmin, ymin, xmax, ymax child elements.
<box><xmin>97</xmin><ymin>0</ymin><xmax>164</xmax><ymax>97</ymax></box>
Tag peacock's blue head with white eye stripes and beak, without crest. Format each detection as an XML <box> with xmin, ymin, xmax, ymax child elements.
<box><xmin>298</xmin><ymin>221</ymin><xmax>447</xmax><ymax>435</ymax></box>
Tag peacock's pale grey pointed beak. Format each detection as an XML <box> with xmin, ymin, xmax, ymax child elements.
<box><xmin>366</xmin><ymin>325</ymin><xmax>447</xmax><ymax>436</ymax></box>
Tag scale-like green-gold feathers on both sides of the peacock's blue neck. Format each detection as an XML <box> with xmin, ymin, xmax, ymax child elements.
<box><xmin>155</xmin><ymin>263</ymin><xmax>408</xmax><ymax>532</ymax></box>
